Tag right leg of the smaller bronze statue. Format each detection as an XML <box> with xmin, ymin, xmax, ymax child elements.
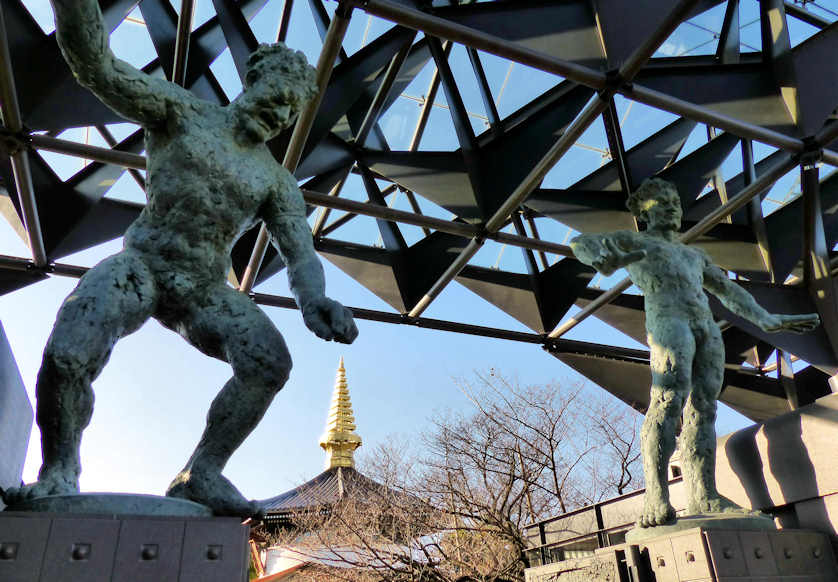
<box><xmin>681</xmin><ymin>322</ymin><xmax>747</xmax><ymax>514</ymax></box>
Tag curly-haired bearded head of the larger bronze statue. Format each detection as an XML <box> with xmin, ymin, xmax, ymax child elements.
<box><xmin>235</xmin><ymin>43</ymin><xmax>317</xmax><ymax>141</ymax></box>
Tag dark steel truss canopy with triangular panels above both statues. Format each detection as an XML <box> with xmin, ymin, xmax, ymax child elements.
<box><xmin>0</xmin><ymin>0</ymin><xmax>838</xmax><ymax>420</ymax></box>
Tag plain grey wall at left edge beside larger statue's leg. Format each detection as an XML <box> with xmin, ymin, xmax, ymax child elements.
<box><xmin>0</xmin><ymin>325</ymin><xmax>33</xmax><ymax>509</ymax></box>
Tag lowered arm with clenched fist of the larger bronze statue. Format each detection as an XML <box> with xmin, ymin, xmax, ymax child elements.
<box><xmin>261</xmin><ymin>169</ymin><xmax>358</xmax><ymax>343</ymax></box>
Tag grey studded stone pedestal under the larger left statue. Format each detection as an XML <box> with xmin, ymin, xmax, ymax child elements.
<box><xmin>0</xmin><ymin>511</ymin><xmax>249</xmax><ymax>582</ymax></box>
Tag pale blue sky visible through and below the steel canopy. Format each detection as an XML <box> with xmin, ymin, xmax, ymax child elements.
<box><xmin>6</xmin><ymin>0</ymin><xmax>836</xmax><ymax>498</ymax></box>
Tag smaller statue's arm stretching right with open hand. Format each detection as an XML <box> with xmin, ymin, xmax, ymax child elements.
<box><xmin>704</xmin><ymin>257</ymin><xmax>820</xmax><ymax>333</ymax></box>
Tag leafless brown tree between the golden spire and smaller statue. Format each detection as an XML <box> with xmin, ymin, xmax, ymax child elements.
<box><xmin>260</xmin><ymin>371</ymin><xmax>639</xmax><ymax>582</ymax></box>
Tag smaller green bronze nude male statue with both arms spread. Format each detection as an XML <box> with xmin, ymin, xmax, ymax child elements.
<box><xmin>570</xmin><ymin>178</ymin><xmax>819</xmax><ymax>527</ymax></box>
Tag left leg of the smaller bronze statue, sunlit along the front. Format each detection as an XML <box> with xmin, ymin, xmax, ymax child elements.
<box><xmin>637</xmin><ymin>318</ymin><xmax>695</xmax><ymax>527</ymax></box>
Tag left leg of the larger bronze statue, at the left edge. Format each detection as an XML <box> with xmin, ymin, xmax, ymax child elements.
<box><xmin>6</xmin><ymin>251</ymin><xmax>156</xmax><ymax>505</ymax></box>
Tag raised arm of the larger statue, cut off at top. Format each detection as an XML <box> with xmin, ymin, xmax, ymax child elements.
<box><xmin>51</xmin><ymin>0</ymin><xmax>190</xmax><ymax>126</ymax></box>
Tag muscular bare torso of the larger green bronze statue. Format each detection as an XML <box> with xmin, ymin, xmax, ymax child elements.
<box><xmin>125</xmin><ymin>104</ymin><xmax>288</xmax><ymax>290</ymax></box>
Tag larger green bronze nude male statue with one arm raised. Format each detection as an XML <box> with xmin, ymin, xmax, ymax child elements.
<box><xmin>0</xmin><ymin>0</ymin><xmax>358</xmax><ymax>516</ymax></box>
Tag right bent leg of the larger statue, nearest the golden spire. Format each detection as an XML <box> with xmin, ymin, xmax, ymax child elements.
<box><xmin>166</xmin><ymin>286</ymin><xmax>291</xmax><ymax>516</ymax></box>
